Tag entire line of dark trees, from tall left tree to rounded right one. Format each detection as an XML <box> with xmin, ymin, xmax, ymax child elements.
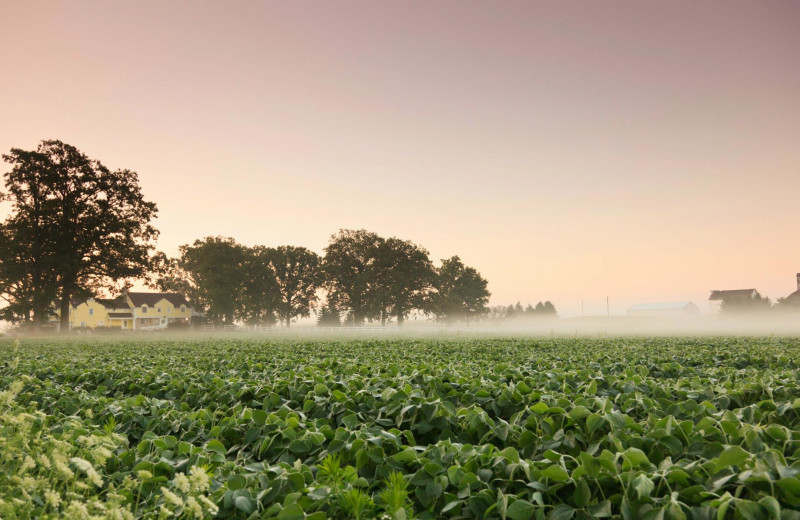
<box><xmin>0</xmin><ymin>140</ymin><xmax>490</xmax><ymax>331</ymax></box>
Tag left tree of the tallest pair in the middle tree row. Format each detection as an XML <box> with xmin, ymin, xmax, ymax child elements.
<box><xmin>323</xmin><ymin>229</ymin><xmax>382</xmax><ymax>325</ymax></box>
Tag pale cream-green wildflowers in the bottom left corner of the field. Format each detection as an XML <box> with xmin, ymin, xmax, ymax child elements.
<box><xmin>0</xmin><ymin>377</ymin><xmax>219</xmax><ymax>520</ymax></box>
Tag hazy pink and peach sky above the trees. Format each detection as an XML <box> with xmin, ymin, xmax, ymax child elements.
<box><xmin>0</xmin><ymin>0</ymin><xmax>800</xmax><ymax>316</ymax></box>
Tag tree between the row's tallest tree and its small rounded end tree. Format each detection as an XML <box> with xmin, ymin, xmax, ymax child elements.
<box><xmin>369</xmin><ymin>237</ymin><xmax>436</xmax><ymax>325</ymax></box>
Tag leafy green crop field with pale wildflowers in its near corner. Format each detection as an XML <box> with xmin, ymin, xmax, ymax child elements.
<box><xmin>0</xmin><ymin>338</ymin><xmax>800</xmax><ymax>520</ymax></box>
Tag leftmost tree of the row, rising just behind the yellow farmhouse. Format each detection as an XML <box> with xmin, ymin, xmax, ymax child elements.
<box><xmin>161</xmin><ymin>236</ymin><xmax>248</xmax><ymax>323</ymax></box>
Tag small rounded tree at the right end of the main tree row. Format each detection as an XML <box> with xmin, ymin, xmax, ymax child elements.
<box><xmin>431</xmin><ymin>256</ymin><xmax>491</xmax><ymax>323</ymax></box>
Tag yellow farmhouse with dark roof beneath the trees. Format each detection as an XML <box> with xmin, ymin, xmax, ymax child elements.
<box><xmin>53</xmin><ymin>292</ymin><xmax>193</xmax><ymax>330</ymax></box>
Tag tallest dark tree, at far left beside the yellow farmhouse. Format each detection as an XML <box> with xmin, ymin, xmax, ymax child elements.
<box><xmin>0</xmin><ymin>140</ymin><xmax>158</xmax><ymax>332</ymax></box>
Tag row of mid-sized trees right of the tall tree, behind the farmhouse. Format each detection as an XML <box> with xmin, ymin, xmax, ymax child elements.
<box><xmin>150</xmin><ymin>233</ymin><xmax>490</xmax><ymax>326</ymax></box>
